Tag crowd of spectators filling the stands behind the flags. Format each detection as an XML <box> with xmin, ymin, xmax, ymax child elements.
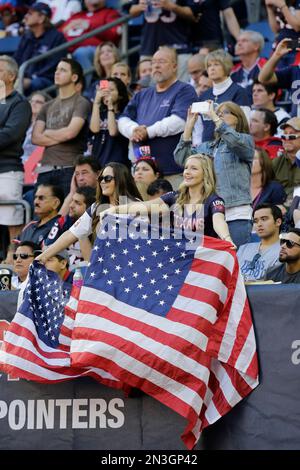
<box><xmin>0</xmin><ymin>0</ymin><xmax>300</xmax><ymax>285</ymax></box>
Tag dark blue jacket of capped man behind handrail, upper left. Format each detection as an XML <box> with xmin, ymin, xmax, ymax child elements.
<box><xmin>14</xmin><ymin>27</ymin><xmax>67</xmax><ymax>80</ymax></box>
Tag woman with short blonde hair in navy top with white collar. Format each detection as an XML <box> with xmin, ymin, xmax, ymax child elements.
<box><xmin>198</xmin><ymin>49</ymin><xmax>251</xmax><ymax>142</ymax></box>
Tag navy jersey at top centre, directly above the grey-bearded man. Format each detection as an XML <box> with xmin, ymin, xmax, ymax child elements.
<box><xmin>132</xmin><ymin>0</ymin><xmax>199</xmax><ymax>56</ymax></box>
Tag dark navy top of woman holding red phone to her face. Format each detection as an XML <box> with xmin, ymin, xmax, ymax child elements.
<box><xmin>92</xmin><ymin>110</ymin><xmax>131</xmax><ymax>168</ymax></box>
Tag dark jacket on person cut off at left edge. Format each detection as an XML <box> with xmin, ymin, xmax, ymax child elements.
<box><xmin>0</xmin><ymin>91</ymin><xmax>31</xmax><ymax>173</ymax></box>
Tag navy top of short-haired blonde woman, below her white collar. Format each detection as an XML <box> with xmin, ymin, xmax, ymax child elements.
<box><xmin>198</xmin><ymin>83</ymin><xmax>251</xmax><ymax>142</ymax></box>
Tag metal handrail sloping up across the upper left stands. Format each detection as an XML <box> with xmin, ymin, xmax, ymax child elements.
<box><xmin>17</xmin><ymin>15</ymin><xmax>131</xmax><ymax>94</ymax></box>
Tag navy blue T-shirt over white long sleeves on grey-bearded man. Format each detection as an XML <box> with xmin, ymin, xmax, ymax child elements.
<box><xmin>121</xmin><ymin>80</ymin><xmax>198</xmax><ymax>175</ymax></box>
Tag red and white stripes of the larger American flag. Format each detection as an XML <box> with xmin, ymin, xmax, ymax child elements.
<box><xmin>71</xmin><ymin>237</ymin><xmax>258</xmax><ymax>449</ymax></box>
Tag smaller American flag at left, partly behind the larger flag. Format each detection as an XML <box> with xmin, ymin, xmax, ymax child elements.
<box><xmin>0</xmin><ymin>261</ymin><xmax>121</xmax><ymax>388</ymax></box>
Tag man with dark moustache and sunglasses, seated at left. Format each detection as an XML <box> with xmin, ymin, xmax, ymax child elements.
<box><xmin>16</xmin><ymin>184</ymin><xmax>64</xmax><ymax>246</ymax></box>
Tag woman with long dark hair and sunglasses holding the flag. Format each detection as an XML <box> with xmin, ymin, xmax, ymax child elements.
<box><xmin>37</xmin><ymin>162</ymin><xmax>141</xmax><ymax>263</ymax></box>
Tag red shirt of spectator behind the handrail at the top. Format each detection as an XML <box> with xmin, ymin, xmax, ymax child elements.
<box><xmin>60</xmin><ymin>8</ymin><xmax>121</xmax><ymax>52</ymax></box>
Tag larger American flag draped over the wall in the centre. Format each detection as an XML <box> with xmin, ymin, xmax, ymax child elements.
<box><xmin>71</xmin><ymin>216</ymin><xmax>258</xmax><ymax>449</ymax></box>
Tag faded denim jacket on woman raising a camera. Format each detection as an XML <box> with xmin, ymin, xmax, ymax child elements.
<box><xmin>174</xmin><ymin>123</ymin><xmax>254</xmax><ymax>208</ymax></box>
